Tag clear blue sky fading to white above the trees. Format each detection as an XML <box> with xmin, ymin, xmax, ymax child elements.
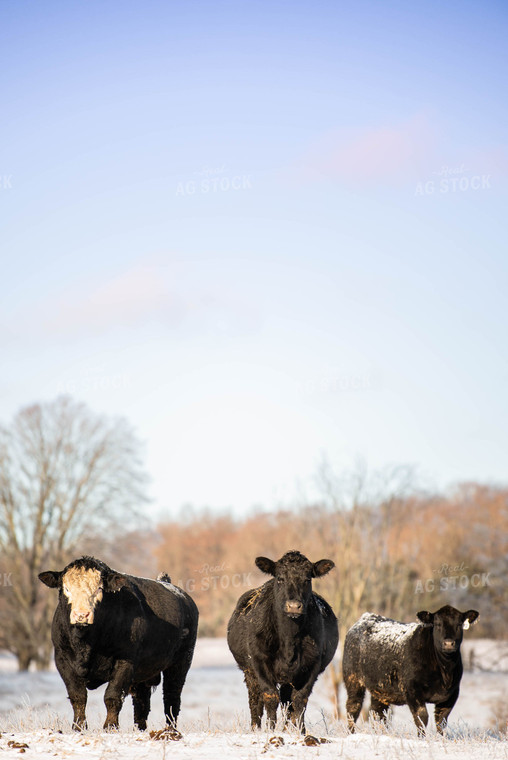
<box><xmin>0</xmin><ymin>1</ymin><xmax>508</xmax><ymax>513</ymax></box>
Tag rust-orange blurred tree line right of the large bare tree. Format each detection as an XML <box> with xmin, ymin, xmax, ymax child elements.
<box><xmin>152</xmin><ymin>476</ymin><xmax>508</xmax><ymax>641</ymax></box>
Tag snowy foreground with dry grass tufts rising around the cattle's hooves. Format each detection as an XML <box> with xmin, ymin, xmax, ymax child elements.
<box><xmin>0</xmin><ymin>697</ymin><xmax>508</xmax><ymax>760</ymax></box>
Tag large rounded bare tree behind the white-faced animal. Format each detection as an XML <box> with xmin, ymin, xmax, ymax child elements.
<box><xmin>0</xmin><ymin>397</ymin><xmax>146</xmax><ymax>670</ymax></box>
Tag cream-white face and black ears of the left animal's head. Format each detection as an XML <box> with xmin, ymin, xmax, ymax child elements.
<box><xmin>39</xmin><ymin>557</ymin><xmax>127</xmax><ymax>626</ymax></box>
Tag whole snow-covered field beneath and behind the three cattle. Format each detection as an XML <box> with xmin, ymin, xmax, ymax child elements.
<box><xmin>0</xmin><ymin>639</ymin><xmax>508</xmax><ymax>760</ymax></box>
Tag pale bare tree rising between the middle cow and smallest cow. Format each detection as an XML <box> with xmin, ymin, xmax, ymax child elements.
<box><xmin>307</xmin><ymin>458</ymin><xmax>415</xmax><ymax>717</ymax></box>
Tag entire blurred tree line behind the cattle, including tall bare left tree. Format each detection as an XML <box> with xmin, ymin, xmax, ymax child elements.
<box><xmin>0</xmin><ymin>397</ymin><xmax>508</xmax><ymax>669</ymax></box>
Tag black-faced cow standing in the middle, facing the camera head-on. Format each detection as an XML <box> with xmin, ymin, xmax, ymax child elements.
<box><xmin>228</xmin><ymin>551</ymin><xmax>339</xmax><ymax>732</ymax></box>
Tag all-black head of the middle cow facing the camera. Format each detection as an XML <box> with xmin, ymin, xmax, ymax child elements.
<box><xmin>256</xmin><ymin>551</ymin><xmax>335</xmax><ymax>619</ymax></box>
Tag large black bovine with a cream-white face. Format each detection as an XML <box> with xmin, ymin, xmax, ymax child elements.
<box><xmin>39</xmin><ymin>557</ymin><xmax>198</xmax><ymax>730</ymax></box>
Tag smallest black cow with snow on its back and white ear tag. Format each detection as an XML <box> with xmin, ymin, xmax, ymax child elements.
<box><xmin>342</xmin><ymin>605</ymin><xmax>479</xmax><ymax>734</ymax></box>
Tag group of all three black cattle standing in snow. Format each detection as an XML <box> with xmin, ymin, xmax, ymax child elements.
<box><xmin>39</xmin><ymin>551</ymin><xmax>478</xmax><ymax>735</ymax></box>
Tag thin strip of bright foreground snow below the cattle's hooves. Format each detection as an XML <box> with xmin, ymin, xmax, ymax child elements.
<box><xmin>0</xmin><ymin>729</ymin><xmax>508</xmax><ymax>760</ymax></box>
